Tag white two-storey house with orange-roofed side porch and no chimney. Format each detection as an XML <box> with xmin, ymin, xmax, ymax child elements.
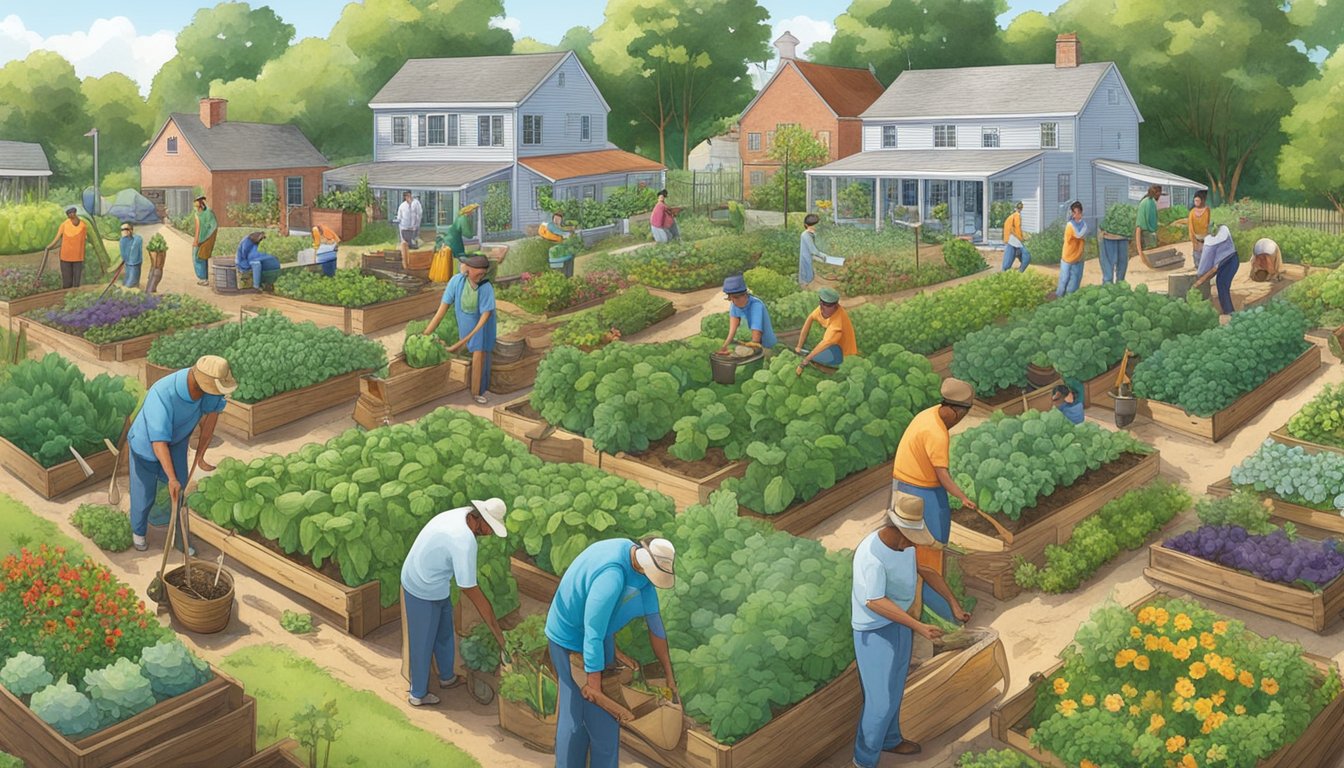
<box><xmin>323</xmin><ymin>51</ymin><xmax>665</xmax><ymax>237</ymax></box>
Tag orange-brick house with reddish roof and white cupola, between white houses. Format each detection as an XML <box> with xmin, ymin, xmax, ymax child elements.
<box><xmin>739</xmin><ymin>32</ymin><xmax>884</xmax><ymax>196</ymax></box>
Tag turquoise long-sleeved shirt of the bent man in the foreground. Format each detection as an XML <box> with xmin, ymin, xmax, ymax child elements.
<box><xmin>546</xmin><ymin>538</ymin><xmax>659</xmax><ymax>673</ymax></box>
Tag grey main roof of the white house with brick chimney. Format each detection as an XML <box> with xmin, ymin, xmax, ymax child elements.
<box><xmin>863</xmin><ymin>62</ymin><xmax>1142</xmax><ymax>120</ymax></box>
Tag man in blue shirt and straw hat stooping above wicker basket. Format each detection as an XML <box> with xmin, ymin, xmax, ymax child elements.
<box><xmin>126</xmin><ymin>355</ymin><xmax>238</xmax><ymax>551</ymax></box>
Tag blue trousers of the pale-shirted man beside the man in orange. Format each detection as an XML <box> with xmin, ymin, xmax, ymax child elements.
<box><xmin>853</xmin><ymin>623</ymin><xmax>914</xmax><ymax>768</ymax></box>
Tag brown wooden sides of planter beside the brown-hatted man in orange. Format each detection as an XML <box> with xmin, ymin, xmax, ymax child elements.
<box><xmin>949</xmin><ymin>452</ymin><xmax>1161</xmax><ymax>600</ymax></box>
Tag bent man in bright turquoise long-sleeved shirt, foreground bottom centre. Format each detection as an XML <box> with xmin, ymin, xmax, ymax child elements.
<box><xmin>546</xmin><ymin>538</ymin><xmax>680</xmax><ymax>768</ymax></box>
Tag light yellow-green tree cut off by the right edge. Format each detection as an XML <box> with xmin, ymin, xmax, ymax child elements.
<box><xmin>1278</xmin><ymin>46</ymin><xmax>1344</xmax><ymax>213</ymax></box>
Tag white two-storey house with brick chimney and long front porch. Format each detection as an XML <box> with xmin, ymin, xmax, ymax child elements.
<box><xmin>806</xmin><ymin>35</ymin><xmax>1203</xmax><ymax>239</ymax></box>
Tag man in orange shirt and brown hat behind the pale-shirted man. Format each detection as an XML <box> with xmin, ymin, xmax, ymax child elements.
<box><xmin>891</xmin><ymin>379</ymin><xmax>976</xmax><ymax>620</ymax></box>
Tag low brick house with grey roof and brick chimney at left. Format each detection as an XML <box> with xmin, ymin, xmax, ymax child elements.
<box><xmin>140</xmin><ymin>98</ymin><xmax>329</xmax><ymax>229</ymax></box>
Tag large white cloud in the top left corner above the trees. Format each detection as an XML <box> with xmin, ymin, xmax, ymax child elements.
<box><xmin>0</xmin><ymin>13</ymin><xmax>177</xmax><ymax>94</ymax></box>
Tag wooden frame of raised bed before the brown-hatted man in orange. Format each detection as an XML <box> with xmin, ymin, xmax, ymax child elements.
<box><xmin>949</xmin><ymin>452</ymin><xmax>1161</xmax><ymax>600</ymax></box>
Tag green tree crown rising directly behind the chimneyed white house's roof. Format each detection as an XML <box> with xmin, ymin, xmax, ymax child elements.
<box><xmin>809</xmin><ymin>0</ymin><xmax>1008</xmax><ymax>82</ymax></box>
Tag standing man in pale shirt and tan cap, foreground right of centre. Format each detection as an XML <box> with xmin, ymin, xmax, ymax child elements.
<box><xmin>851</xmin><ymin>491</ymin><xmax>970</xmax><ymax>768</ymax></box>
